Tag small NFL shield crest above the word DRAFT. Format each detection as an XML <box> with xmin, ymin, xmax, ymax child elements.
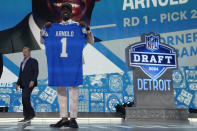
<box><xmin>145</xmin><ymin>34</ymin><xmax>159</xmax><ymax>51</ymax></box>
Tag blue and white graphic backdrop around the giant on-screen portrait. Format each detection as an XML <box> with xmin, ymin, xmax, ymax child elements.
<box><xmin>0</xmin><ymin>0</ymin><xmax>197</xmax><ymax>112</ymax></box>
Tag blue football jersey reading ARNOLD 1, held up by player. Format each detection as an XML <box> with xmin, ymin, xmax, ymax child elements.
<box><xmin>43</xmin><ymin>23</ymin><xmax>87</xmax><ymax>86</ymax></box>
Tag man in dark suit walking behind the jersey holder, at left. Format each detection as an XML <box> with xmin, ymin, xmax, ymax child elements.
<box><xmin>15</xmin><ymin>47</ymin><xmax>38</xmax><ymax>122</ymax></box>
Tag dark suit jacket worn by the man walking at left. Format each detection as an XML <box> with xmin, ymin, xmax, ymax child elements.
<box><xmin>17</xmin><ymin>57</ymin><xmax>39</xmax><ymax>88</ymax></box>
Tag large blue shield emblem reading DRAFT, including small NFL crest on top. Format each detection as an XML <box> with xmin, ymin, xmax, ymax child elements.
<box><xmin>126</xmin><ymin>33</ymin><xmax>177</xmax><ymax>79</ymax></box>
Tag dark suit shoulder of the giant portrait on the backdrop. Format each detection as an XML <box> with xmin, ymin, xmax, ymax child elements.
<box><xmin>0</xmin><ymin>14</ymin><xmax>40</xmax><ymax>54</ymax></box>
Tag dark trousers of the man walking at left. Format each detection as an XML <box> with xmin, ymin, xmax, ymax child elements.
<box><xmin>22</xmin><ymin>87</ymin><xmax>35</xmax><ymax>118</ymax></box>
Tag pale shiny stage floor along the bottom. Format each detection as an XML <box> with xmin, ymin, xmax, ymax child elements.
<box><xmin>0</xmin><ymin>118</ymin><xmax>197</xmax><ymax>131</ymax></box>
